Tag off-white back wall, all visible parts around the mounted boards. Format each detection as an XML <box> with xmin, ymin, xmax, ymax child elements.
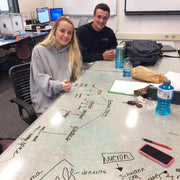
<box><xmin>19</xmin><ymin>0</ymin><xmax>180</xmax><ymax>40</ymax></box>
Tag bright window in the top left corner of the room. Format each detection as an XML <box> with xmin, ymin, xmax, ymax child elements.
<box><xmin>0</xmin><ymin>0</ymin><xmax>19</xmax><ymax>13</ymax></box>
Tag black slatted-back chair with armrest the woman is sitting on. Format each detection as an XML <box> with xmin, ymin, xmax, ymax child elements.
<box><xmin>9</xmin><ymin>62</ymin><xmax>37</xmax><ymax>124</ymax></box>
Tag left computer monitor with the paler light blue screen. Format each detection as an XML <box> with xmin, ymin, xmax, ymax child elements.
<box><xmin>36</xmin><ymin>7</ymin><xmax>51</xmax><ymax>24</ymax></box>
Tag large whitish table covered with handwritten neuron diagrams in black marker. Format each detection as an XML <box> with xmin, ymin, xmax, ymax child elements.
<box><xmin>0</xmin><ymin>53</ymin><xmax>180</xmax><ymax>180</ymax></box>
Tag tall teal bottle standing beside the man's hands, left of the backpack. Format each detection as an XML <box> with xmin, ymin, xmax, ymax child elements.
<box><xmin>115</xmin><ymin>46</ymin><xmax>124</xmax><ymax>69</ymax></box>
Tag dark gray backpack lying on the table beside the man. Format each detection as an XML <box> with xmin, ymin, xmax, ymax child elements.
<box><xmin>125</xmin><ymin>40</ymin><xmax>163</xmax><ymax>67</ymax></box>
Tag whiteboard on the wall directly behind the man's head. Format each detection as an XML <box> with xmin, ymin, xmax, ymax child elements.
<box><xmin>54</xmin><ymin>0</ymin><xmax>117</xmax><ymax>16</ymax></box>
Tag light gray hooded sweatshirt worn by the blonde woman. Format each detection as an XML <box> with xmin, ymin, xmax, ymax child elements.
<box><xmin>30</xmin><ymin>45</ymin><xmax>71</xmax><ymax>114</ymax></box>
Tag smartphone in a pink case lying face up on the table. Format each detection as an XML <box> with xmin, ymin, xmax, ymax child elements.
<box><xmin>139</xmin><ymin>144</ymin><xmax>174</xmax><ymax>167</ymax></box>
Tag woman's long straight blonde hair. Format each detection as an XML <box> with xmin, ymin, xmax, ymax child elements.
<box><xmin>39</xmin><ymin>16</ymin><xmax>81</xmax><ymax>79</ymax></box>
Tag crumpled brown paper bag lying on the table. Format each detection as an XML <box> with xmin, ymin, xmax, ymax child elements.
<box><xmin>131</xmin><ymin>66</ymin><xmax>167</xmax><ymax>84</ymax></box>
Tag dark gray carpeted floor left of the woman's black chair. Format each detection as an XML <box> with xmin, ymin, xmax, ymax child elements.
<box><xmin>0</xmin><ymin>71</ymin><xmax>29</xmax><ymax>138</ymax></box>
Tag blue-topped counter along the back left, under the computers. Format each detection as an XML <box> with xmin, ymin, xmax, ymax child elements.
<box><xmin>0</xmin><ymin>32</ymin><xmax>48</xmax><ymax>48</ymax></box>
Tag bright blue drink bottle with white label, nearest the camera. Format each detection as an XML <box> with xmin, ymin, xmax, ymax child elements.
<box><xmin>156</xmin><ymin>79</ymin><xmax>174</xmax><ymax>115</ymax></box>
